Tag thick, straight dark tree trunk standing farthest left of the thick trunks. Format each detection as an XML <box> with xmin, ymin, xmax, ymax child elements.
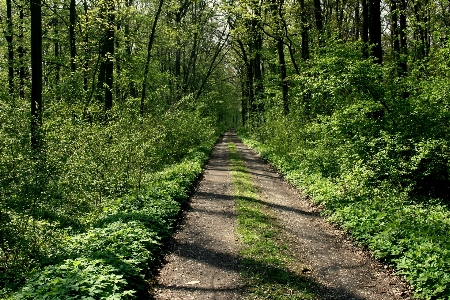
<box><xmin>30</xmin><ymin>0</ymin><xmax>42</xmax><ymax>153</ymax></box>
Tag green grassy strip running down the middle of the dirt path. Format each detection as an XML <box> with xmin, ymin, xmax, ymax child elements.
<box><xmin>228</xmin><ymin>143</ymin><xmax>315</xmax><ymax>299</ymax></box>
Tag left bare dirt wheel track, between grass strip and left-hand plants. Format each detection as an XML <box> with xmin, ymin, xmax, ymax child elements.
<box><xmin>155</xmin><ymin>133</ymin><xmax>242</xmax><ymax>300</ymax></box>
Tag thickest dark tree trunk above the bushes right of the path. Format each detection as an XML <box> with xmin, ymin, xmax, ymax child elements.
<box><xmin>369</xmin><ymin>0</ymin><xmax>383</xmax><ymax>64</ymax></box>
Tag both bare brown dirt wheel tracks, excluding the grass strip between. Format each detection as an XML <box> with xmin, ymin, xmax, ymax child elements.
<box><xmin>151</xmin><ymin>131</ymin><xmax>412</xmax><ymax>300</ymax></box>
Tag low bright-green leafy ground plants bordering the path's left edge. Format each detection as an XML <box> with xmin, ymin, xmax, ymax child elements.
<box><xmin>3</xmin><ymin>137</ymin><xmax>218</xmax><ymax>300</ymax></box>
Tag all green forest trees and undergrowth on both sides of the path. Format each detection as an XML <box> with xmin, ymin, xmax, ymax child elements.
<box><xmin>0</xmin><ymin>0</ymin><xmax>450</xmax><ymax>299</ymax></box>
